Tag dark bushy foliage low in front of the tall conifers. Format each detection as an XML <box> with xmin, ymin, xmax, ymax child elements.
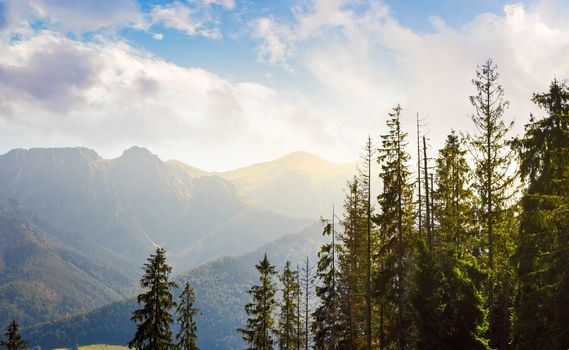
<box><xmin>412</xmin><ymin>242</ymin><xmax>488</xmax><ymax>350</ymax></box>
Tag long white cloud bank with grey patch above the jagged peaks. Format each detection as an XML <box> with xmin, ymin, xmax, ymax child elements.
<box><xmin>0</xmin><ymin>31</ymin><xmax>336</xmax><ymax>168</ymax></box>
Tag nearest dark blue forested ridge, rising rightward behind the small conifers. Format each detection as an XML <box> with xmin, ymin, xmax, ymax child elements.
<box><xmin>24</xmin><ymin>225</ymin><xmax>322</xmax><ymax>349</ymax></box>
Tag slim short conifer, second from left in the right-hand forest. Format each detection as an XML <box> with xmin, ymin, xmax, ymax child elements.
<box><xmin>277</xmin><ymin>261</ymin><xmax>300</xmax><ymax>350</ymax></box>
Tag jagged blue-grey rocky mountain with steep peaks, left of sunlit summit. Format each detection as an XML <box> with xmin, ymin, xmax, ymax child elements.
<box><xmin>0</xmin><ymin>147</ymin><xmax>310</xmax><ymax>269</ymax></box>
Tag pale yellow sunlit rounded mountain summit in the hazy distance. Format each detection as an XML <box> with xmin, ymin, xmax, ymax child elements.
<box><xmin>170</xmin><ymin>152</ymin><xmax>356</xmax><ymax>219</ymax></box>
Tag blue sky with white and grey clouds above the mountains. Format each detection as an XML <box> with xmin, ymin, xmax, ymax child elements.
<box><xmin>0</xmin><ymin>0</ymin><xmax>569</xmax><ymax>171</ymax></box>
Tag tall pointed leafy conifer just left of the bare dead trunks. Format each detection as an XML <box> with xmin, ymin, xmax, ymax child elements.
<box><xmin>376</xmin><ymin>106</ymin><xmax>414</xmax><ymax>350</ymax></box>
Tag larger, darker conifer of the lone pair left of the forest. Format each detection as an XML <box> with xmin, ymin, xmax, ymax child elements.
<box><xmin>128</xmin><ymin>248</ymin><xmax>176</xmax><ymax>350</ymax></box>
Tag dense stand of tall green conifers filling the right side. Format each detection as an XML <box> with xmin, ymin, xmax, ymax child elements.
<box><xmin>233</xmin><ymin>60</ymin><xmax>569</xmax><ymax>349</ymax></box>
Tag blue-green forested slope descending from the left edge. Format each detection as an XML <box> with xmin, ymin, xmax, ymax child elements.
<box><xmin>0</xmin><ymin>197</ymin><xmax>135</xmax><ymax>326</ymax></box>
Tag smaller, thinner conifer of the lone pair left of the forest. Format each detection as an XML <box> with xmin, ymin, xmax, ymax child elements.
<box><xmin>176</xmin><ymin>282</ymin><xmax>199</xmax><ymax>350</ymax></box>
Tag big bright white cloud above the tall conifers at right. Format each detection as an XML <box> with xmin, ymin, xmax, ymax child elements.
<box><xmin>253</xmin><ymin>0</ymin><xmax>569</xmax><ymax>158</ymax></box>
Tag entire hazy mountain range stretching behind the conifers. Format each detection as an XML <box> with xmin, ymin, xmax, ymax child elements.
<box><xmin>0</xmin><ymin>147</ymin><xmax>354</xmax><ymax>349</ymax></box>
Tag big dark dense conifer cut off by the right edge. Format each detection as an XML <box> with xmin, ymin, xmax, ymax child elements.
<box><xmin>513</xmin><ymin>80</ymin><xmax>569</xmax><ymax>349</ymax></box>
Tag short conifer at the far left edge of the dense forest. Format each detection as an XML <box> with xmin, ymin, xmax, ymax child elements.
<box><xmin>238</xmin><ymin>254</ymin><xmax>277</xmax><ymax>350</ymax></box>
